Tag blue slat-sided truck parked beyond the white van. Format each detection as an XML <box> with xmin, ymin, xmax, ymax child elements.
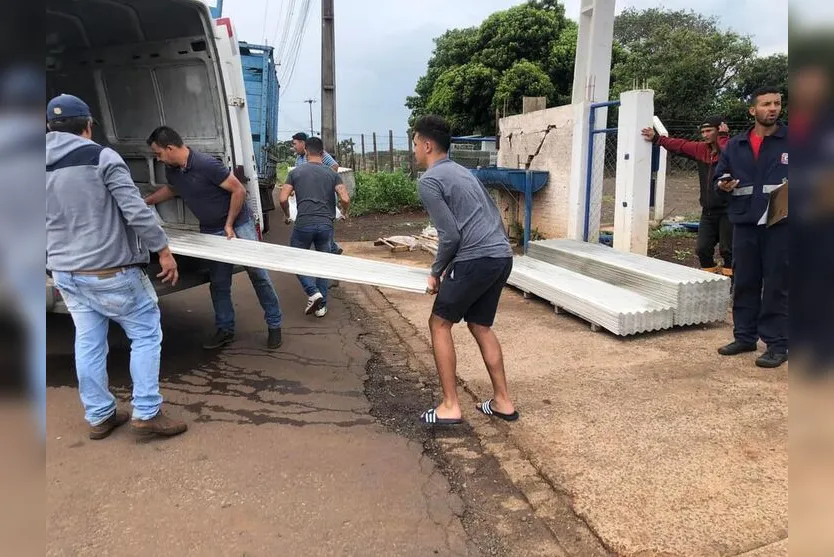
<box><xmin>238</xmin><ymin>41</ymin><xmax>280</xmax><ymax>232</ymax></box>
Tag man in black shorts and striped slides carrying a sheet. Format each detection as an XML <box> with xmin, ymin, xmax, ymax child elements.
<box><xmin>414</xmin><ymin>116</ymin><xmax>518</xmax><ymax>425</ymax></box>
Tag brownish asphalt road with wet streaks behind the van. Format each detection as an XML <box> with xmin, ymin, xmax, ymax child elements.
<box><xmin>46</xmin><ymin>226</ymin><xmax>477</xmax><ymax>556</ymax></box>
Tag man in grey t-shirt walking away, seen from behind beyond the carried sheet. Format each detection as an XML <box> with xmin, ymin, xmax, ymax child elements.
<box><xmin>280</xmin><ymin>137</ymin><xmax>350</xmax><ymax>317</ymax></box>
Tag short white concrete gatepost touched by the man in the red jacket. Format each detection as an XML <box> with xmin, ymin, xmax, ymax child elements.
<box><xmin>614</xmin><ymin>90</ymin><xmax>654</xmax><ymax>255</ymax></box>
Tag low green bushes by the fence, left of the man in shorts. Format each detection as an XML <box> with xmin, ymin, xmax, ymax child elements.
<box><xmin>350</xmin><ymin>170</ymin><xmax>421</xmax><ymax>217</ymax></box>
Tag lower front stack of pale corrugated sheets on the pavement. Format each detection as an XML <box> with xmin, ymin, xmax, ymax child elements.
<box><xmin>509</xmin><ymin>256</ymin><xmax>675</xmax><ymax>336</ymax></box>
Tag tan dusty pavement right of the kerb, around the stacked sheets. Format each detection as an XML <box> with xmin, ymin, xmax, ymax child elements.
<box><xmin>339</xmin><ymin>205</ymin><xmax>788</xmax><ymax>557</ymax></box>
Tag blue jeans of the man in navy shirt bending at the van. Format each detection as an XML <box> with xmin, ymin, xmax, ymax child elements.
<box><xmin>209</xmin><ymin>219</ymin><xmax>281</xmax><ymax>333</ymax></box>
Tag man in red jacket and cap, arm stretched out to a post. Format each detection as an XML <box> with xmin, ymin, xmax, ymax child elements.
<box><xmin>643</xmin><ymin>116</ymin><xmax>733</xmax><ymax>277</ymax></box>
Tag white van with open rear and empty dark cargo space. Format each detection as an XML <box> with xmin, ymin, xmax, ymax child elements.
<box><xmin>46</xmin><ymin>0</ymin><xmax>263</xmax><ymax>312</ymax></box>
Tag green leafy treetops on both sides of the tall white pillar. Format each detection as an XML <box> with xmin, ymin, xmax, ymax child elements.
<box><xmin>406</xmin><ymin>4</ymin><xmax>787</xmax><ymax>134</ymax></box>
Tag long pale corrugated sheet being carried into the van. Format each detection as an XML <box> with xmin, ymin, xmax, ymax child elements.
<box><xmin>165</xmin><ymin>228</ymin><xmax>429</xmax><ymax>294</ymax></box>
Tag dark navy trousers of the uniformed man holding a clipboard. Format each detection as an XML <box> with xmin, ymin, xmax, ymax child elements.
<box><xmin>733</xmin><ymin>222</ymin><xmax>790</xmax><ymax>352</ymax></box>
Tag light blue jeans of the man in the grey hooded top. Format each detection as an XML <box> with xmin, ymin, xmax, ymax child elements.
<box><xmin>52</xmin><ymin>267</ymin><xmax>162</xmax><ymax>425</ymax></box>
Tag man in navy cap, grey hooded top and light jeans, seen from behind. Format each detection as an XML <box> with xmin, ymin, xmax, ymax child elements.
<box><xmin>46</xmin><ymin>95</ymin><xmax>186</xmax><ymax>439</ymax></box>
